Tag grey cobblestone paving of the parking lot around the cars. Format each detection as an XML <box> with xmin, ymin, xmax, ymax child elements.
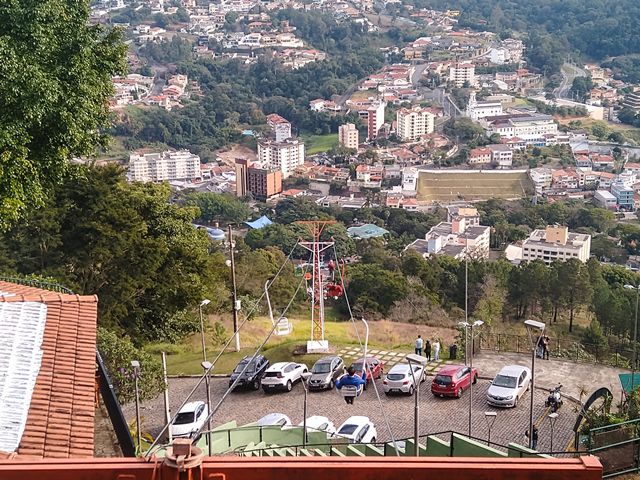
<box><xmin>125</xmin><ymin>377</ymin><xmax>575</xmax><ymax>451</ymax></box>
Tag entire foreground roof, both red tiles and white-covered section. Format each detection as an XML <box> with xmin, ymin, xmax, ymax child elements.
<box><xmin>0</xmin><ymin>281</ymin><xmax>98</xmax><ymax>456</ymax></box>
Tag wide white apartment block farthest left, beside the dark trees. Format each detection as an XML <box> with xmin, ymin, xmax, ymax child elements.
<box><xmin>128</xmin><ymin>150</ymin><xmax>202</xmax><ymax>182</ymax></box>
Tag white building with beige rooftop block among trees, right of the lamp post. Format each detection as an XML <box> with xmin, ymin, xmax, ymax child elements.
<box><xmin>522</xmin><ymin>225</ymin><xmax>591</xmax><ymax>265</ymax></box>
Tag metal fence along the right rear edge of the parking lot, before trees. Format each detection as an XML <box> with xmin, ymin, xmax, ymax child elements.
<box><xmin>474</xmin><ymin>332</ymin><xmax>633</xmax><ymax>368</ymax></box>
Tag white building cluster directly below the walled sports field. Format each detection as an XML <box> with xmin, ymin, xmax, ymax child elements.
<box><xmin>405</xmin><ymin>215</ymin><xmax>491</xmax><ymax>259</ymax></box>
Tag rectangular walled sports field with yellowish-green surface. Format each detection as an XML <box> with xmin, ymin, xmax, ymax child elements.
<box><xmin>418</xmin><ymin>170</ymin><xmax>533</xmax><ymax>202</ymax></box>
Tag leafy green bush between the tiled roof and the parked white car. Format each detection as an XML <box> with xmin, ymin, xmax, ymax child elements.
<box><xmin>98</xmin><ymin>327</ymin><xmax>164</xmax><ymax>404</ymax></box>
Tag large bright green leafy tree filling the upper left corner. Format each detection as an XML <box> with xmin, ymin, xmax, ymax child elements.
<box><xmin>0</xmin><ymin>0</ymin><xmax>126</xmax><ymax>229</ymax></box>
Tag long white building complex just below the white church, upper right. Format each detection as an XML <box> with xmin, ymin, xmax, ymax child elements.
<box><xmin>481</xmin><ymin>114</ymin><xmax>558</xmax><ymax>146</ymax></box>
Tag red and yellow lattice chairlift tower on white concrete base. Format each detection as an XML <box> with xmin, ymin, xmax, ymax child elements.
<box><xmin>296</xmin><ymin>220</ymin><xmax>336</xmax><ymax>353</ymax></box>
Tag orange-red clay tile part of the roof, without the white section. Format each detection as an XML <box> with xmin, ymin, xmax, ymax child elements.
<box><xmin>0</xmin><ymin>281</ymin><xmax>98</xmax><ymax>458</ymax></box>
